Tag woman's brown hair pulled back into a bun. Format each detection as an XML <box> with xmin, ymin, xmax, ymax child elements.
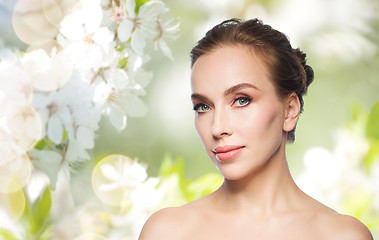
<box><xmin>191</xmin><ymin>18</ymin><xmax>314</xmax><ymax>142</ymax></box>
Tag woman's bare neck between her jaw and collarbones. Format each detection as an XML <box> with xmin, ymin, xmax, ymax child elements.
<box><xmin>219</xmin><ymin>139</ymin><xmax>301</xmax><ymax>213</ymax></box>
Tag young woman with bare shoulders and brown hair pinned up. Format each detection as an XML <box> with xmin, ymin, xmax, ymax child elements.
<box><xmin>140</xmin><ymin>19</ymin><xmax>373</xmax><ymax>240</ymax></box>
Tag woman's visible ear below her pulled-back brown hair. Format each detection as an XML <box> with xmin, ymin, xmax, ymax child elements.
<box><xmin>283</xmin><ymin>93</ymin><xmax>301</xmax><ymax>132</ymax></box>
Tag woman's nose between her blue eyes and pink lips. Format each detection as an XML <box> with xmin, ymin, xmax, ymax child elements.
<box><xmin>212</xmin><ymin>110</ymin><xmax>233</xmax><ymax>140</ymax></box>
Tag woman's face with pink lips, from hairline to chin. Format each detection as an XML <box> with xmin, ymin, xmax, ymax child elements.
<box><xmin>191</xmin><ymin>46</ymin><xmax>286</xmax><ymax>180</ymax></box>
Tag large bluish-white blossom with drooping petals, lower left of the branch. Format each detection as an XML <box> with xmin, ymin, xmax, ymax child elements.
<box><xmin>34</xmin><ymin>74</ymin><xmax>100</xmax><ymax>163</ymax></box>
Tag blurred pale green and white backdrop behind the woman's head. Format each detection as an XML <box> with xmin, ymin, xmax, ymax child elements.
<box><xmin>0</xmin><ymin>0</ymin><xmax>379</xmax><ymax>192</ymax></box>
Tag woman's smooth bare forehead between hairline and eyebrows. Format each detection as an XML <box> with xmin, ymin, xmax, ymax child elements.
<box><xmin>191</xmin><ymin>45</ymin><xmax>272</xmax><ymax>92</ymax></box>
